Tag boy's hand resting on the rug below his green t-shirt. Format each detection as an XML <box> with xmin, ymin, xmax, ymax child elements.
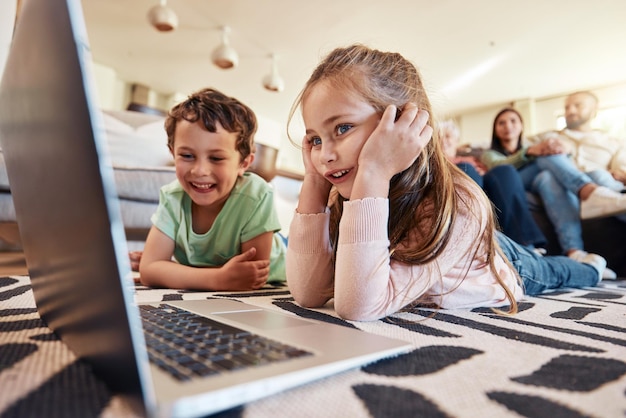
<box><xmin>222</xmin><ymin>247</ymin><xmax>270</xmax><ymax>290</ymax></box>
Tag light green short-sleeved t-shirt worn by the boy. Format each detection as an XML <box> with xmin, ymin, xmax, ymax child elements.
<box><xmin>151</xmin><ymin>173</ymin><xmax>286</xmax><ymax>282</ymax></box>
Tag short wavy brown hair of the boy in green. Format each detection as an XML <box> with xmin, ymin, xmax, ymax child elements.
<box><xmin>165</xmin><ymin>88</ymin><xmax>257</xmax><ymax>160</ymax></box>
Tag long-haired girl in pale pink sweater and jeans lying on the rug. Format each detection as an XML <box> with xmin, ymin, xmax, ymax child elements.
<box><xmin>287</xmin><ymin>45</ymin><xmax>605</xmax><ymax>320</ymax></box>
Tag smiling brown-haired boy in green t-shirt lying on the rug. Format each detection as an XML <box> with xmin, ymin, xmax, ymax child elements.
<box><xmin>135</xmin><ymin>89</ymin><xmax>286</xmax><ymax>290</ymax></box>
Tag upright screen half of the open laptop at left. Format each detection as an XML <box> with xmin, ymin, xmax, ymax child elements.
<box><xmin>0</xmin><ymin>0</ymin><xmax>150</xmax><ymax>404</ymax></box>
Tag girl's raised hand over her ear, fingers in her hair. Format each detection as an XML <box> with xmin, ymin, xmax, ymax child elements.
<box><xmin>359</xmin><ymin>103</ymin><xmax>433</xmax><ymax>180</ymax></box>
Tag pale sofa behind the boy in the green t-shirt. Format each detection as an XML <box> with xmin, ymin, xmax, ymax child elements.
<box><xmin>0</xmin><ymin>110</ymin><xmax>301</xmax><ymax>250</ymax></box>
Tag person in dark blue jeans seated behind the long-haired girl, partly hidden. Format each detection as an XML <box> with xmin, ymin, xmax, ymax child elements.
<box><xmin>439</xmin><ymin>120</ymin><xmax>546</xmax><ymax>254</ymax></box>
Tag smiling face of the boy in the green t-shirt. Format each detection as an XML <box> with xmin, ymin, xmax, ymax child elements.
<box><xmin>172</xmin><ymin>120</ymin><xmax>254</xmax><ymax>211</ymax></box>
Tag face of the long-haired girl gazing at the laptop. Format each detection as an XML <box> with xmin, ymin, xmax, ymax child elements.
<box><xmin>302</xmin><ymin>81</ymin><xmax>378</xmax><ymax>199</ymax></box>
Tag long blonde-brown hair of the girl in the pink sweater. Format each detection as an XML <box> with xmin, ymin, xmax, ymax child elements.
<box><xmin>289</xmin><ymin>44</ymin><xmax>517</xmax><ymax>312</ymax></box>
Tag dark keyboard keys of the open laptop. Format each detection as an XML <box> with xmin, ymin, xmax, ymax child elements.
<box><xmin>139</xmin><ymin>304</ymin><xmax>311</xmax><ymax>381</ymax></box>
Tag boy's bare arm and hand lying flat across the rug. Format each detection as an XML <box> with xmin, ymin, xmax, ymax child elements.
<box><xmin>139</xmin><ymin>226</ymin><xmax>269</xmax><ymax>290</ymax></box>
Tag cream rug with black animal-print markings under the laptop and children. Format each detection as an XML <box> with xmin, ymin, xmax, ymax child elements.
<box><xmin>0</xmin><ymin>276</ymin><xmax>626</xmax><ymax>418</ymax></box>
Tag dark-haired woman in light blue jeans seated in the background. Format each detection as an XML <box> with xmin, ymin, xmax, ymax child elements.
<box><xmin>482</xmin><ymin>108</ymin><xmax>626</xmax><ymax>279</ymax></box>
